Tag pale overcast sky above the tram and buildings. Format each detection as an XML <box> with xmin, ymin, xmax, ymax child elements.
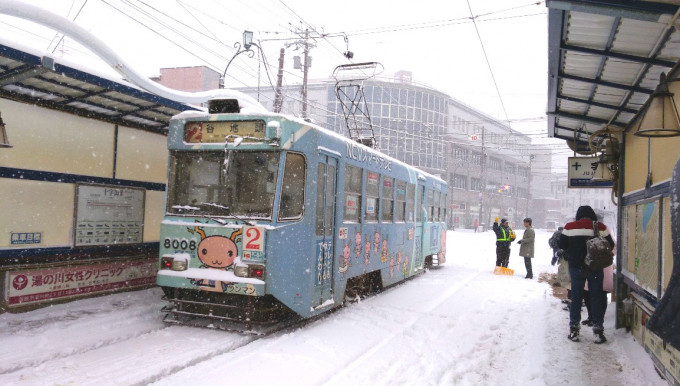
<box><xmin>0</xmin><ymin>0</ymin><xmax>566</xmax><ymax>169</ymax></box>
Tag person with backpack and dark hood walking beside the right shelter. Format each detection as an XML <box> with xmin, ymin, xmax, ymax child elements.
<box><xmin>559</xmin><ymin>205</ymin><xmax>614</xmax><ymax>343</ymax></box>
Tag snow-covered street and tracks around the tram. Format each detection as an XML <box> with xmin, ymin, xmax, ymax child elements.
<box><xmin>0</xmin><ymin>230</ymin><xmax>666</xmax><ymax>385</ymax></box>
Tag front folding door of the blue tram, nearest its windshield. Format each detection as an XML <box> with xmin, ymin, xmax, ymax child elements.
<box><xmin>312</xmin><ymin>154</ymin><xmax>338</xmax><ymax>306</ymax></box>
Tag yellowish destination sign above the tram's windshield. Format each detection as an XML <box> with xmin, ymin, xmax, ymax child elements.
<box><xmin>184</xmin><ymin>121</ymin><xmax>265</xmax><ymax>143</ymax></box>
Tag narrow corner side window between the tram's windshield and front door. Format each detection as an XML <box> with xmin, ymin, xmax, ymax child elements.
<box><xmin>279</xmin><ymin>153</ymin><xmax>305</xmax><ymax>221</ymax></box>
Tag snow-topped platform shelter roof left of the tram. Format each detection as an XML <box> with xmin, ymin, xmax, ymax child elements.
<box><xmin>0</xmin><ymin>38</ymin><xmax>198</xmax><ymax>134</ymax></box>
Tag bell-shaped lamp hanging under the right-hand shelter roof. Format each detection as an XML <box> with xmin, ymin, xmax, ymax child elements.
<box><xmin>634</xmin><ymin>73</ymin><xmax>680</xmax><ymax>138</ymax></box>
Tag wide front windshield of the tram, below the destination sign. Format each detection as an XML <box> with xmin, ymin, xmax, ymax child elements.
<box><xmin>167</xmin><ymin>151</ymin><xmax>280</xmax><ymax>219</ymax></box>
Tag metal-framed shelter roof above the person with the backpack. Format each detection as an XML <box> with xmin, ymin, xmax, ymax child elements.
<box><xmin>546</xmin><ymin>0</ymin><xmax>680</xmax><ymax>151</ymax></box>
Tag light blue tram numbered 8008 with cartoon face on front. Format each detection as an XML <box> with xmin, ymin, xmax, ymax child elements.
<box><xmin>157</xmin><ymin>100</ymin><xmax>447</xmax><ymax>332</ymax></box>
